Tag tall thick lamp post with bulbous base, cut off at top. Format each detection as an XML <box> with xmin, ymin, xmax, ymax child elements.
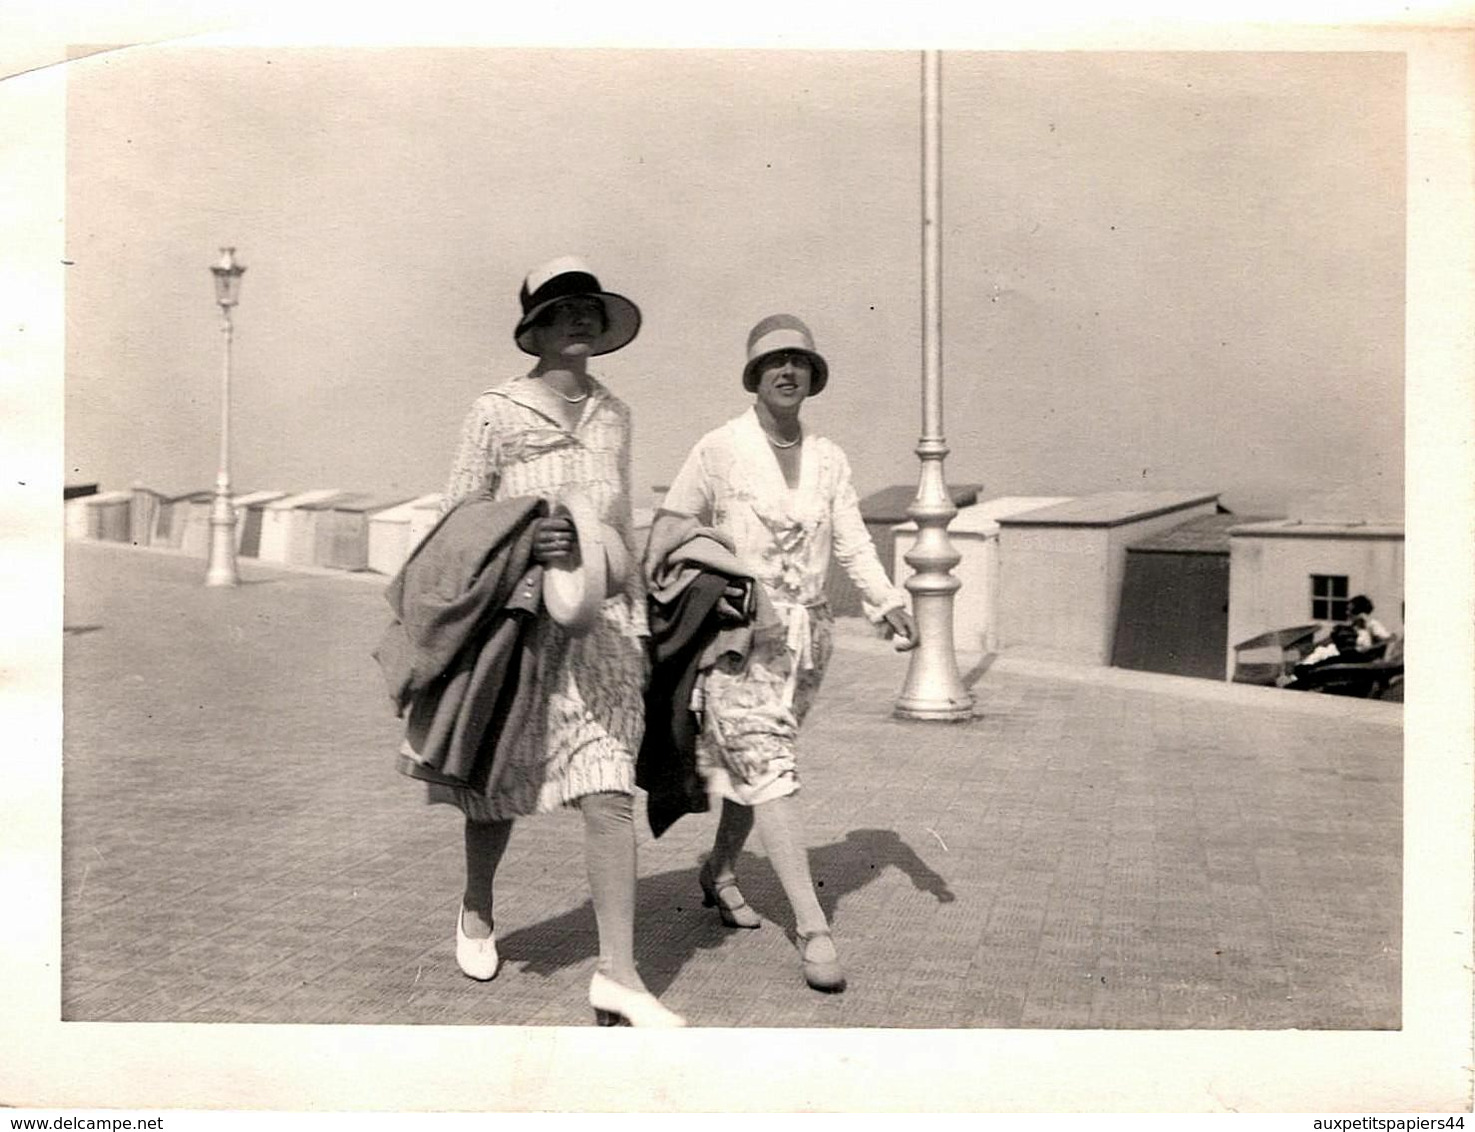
<box><xmin>895</xmin><ymin>52</ymin><xmax>974</xmax><ymax>720</ymax></box>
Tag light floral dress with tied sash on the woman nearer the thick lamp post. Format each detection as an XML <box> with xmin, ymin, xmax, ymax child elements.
<box><xmin>662</xmin><ymin>409</ymin><xmax>906</xmax><ymax>806</ymax></box>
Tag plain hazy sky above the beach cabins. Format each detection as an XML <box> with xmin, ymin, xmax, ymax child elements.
<box><xmin>66</xmin><ymin>47</ymin><xmax>1404</xmax><ymax>512</ymax></box>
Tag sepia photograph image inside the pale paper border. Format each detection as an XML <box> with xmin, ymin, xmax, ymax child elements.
<box><xmin>2</xmin><ymin>6</ymin><xmax>1469</xmax><ymax>1111</ymax></box>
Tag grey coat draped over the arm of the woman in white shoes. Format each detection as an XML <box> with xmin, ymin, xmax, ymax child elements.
<box><xmin>373</xmin><ymin>494</ymin><xmax>547</xmax><ymax>794</ymax></box>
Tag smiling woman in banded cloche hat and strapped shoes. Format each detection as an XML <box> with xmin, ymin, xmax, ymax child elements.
<box><xmin>648</xmin><ymin>314</ymin><xmax>916</xmax><ymax>992</ymax></box>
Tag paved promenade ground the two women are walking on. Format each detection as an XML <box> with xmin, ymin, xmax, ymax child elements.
<box><xmin>62</xmin><ymin>543</ymin><xmax>1403</xmax><ymax>1029</ymax></box>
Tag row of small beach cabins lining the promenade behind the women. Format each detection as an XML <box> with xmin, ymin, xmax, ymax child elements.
<box><xmin>65</xmin><ymin>484</ymin><xmax>1403</xmax><ymax>682</ymax></box>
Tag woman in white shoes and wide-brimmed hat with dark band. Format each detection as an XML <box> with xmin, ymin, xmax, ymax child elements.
<box><xmin>429</xmin><ymin>257</ymin><xmax>683</xmax><ymax>1026</ymax></box>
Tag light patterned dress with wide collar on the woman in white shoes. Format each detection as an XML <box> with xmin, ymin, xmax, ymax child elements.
<box><xmin>429</xmin><ymin>378</ymin><xmax>649</xmax><ymax>821</ymax></box>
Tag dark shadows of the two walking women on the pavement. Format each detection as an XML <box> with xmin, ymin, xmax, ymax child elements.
<box><xmin>497</xmin><ymin>829</ymin><xmax>956</xmax><ymax>995</ymax></box>
